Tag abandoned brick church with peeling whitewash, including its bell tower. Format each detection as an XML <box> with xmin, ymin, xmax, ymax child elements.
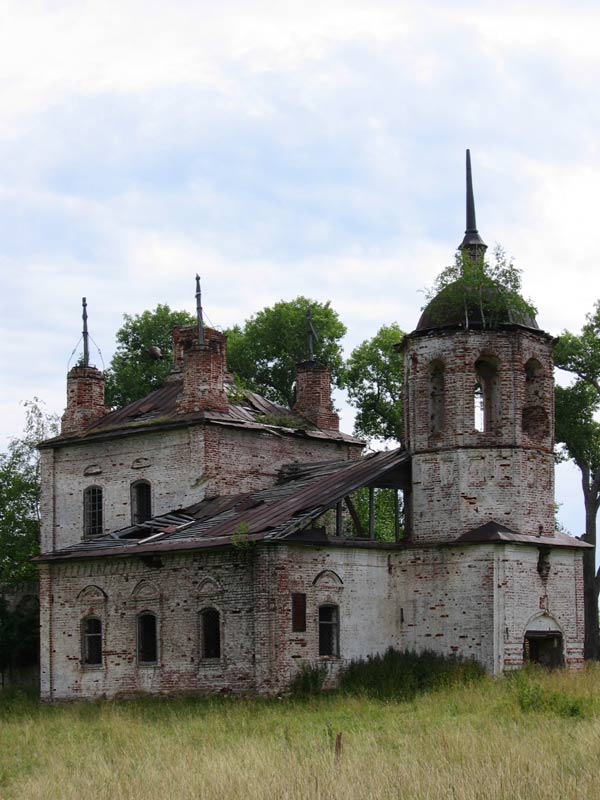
<box><xmin>36</xmin><ymin>153</ymin><xmax>586</xmax><ymax>700</ymax></box>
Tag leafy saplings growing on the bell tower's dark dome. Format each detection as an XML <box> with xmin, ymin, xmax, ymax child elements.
<box><xmin>426</xmin><ymin>246</ymin><xmax>536</xmax><ymax>328</ymax></box>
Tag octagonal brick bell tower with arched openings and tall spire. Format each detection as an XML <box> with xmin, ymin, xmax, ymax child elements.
<box><xmin>403</xmin><ymin>150</ymin><xmax>554</xmax><ymax>544</ymax></box>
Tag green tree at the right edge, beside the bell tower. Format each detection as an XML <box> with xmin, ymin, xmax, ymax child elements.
<box><xmin>554</xmin><ymin>302</ymin><xmax>600</xmax><ymax>658</ymax></box>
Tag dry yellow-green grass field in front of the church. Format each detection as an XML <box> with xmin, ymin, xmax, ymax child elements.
<box><xmin>0</xmin><ymin>667</ymin><xmax>600</xmax><ymax>800</ymax></box>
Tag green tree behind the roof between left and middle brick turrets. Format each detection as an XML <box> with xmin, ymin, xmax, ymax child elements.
<box><xmin>106</xmin><ymin>304</ymin><xmax>196</xmax><ymax>408</ymax></box>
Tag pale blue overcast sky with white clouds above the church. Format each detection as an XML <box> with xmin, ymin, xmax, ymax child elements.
<box><xmin>0</xmin><ymin>0</ymin><xmax>600</xmax><ymax>533</ymax></box>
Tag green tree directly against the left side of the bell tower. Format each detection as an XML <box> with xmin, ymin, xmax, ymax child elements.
<box><xmin>346</xmin><ymin>322</ymin><xmax>404</xmax><ymax>442</ymax></box>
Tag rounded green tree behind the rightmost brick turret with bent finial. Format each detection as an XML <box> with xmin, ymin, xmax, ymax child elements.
<box><xmin>225</xmin><ymin>297</ymin><xmax>346</xmax><ymax>406</ymax></box>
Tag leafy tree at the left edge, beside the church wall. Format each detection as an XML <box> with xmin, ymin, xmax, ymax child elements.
<box><xmin>0</xmin><ymin>398</ymin><xmax>58</xmax><ymax>587</ymax></box>
